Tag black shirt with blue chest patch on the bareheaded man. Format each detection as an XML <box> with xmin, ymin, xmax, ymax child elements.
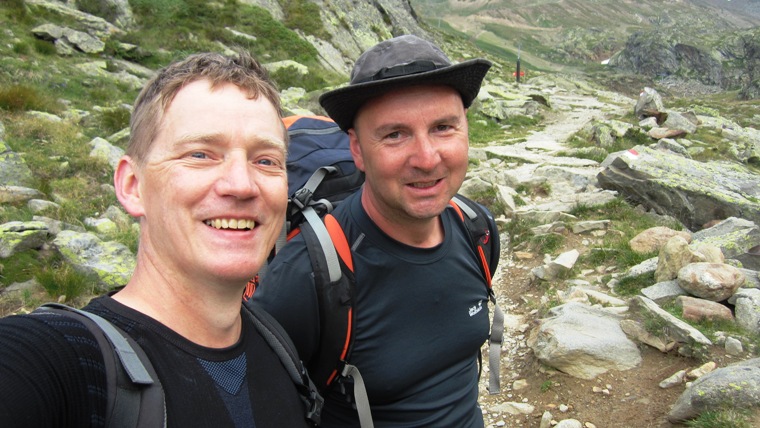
<box><xmin>0</xmin><ymin>297</ymin><xmax>310</xmax><ymax>428</ymax></box>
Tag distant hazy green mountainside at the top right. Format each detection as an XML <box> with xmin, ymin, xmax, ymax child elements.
<box><xmin>414</xmin><ymin>0</ymin><xmax>760</xmax><ymax>99</ymax></box>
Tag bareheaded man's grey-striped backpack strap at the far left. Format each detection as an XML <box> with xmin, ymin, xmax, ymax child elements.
<box><xmin>35</xmin><ymin>303</ymin><xmax>166</xmax><ymax>428</ymax></box>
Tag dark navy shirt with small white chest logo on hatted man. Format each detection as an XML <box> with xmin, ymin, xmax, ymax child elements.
<box><xmin>253</xmin><ymin>191</ymin><xmax>489</xmax><ymax>427</ymax></box>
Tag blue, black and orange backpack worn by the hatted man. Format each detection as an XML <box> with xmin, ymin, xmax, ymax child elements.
<box><xmin>245</xmin><ymin>116</ymin><xmax>504</xmax><ymax>428</ymax></box>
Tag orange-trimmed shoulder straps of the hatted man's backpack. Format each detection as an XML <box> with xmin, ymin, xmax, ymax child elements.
<box><xmin>300</xmin><ymin>196</ymin><xmax>504</xmax><ymax>428</ymax></box>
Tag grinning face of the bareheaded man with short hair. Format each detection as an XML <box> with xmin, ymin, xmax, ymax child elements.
<box><xmin>117</xmin><ymin>80</ymin><xmax>287</xmax><ymax>285</ymax></box>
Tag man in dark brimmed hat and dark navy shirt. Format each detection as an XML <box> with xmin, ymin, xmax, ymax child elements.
<box><xmin>254</xmin><ymin>36</ymin><xmax>491</xmax><ymax>427</ymax></box>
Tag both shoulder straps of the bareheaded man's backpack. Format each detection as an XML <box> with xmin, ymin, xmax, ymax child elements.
<box><xmin>32</xmin><ymin>303</ymin><xmax>323</xmax><ymax>428</ymax></box>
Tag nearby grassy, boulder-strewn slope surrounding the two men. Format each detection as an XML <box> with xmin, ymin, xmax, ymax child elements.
<box><xmin>0</xmin><ymin>0</ymin><xmax>760</xmax><ymax>428</ymax></box>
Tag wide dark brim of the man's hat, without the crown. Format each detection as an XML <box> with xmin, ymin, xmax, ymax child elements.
<box><xmin>319</xmin><ymin>59</ymin><xmax>491</xmax><ymax>131</ymax></box>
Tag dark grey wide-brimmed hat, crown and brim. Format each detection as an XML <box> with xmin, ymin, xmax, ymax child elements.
<box><xmin>319</xmin><ymin>35</ymin><xmax>491</xmax><ymax>131</ymax></box>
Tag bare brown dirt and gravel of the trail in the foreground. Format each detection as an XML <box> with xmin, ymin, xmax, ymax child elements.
<box><xmin>481</xmin><ymin>243</ymin><xmax>700</xmax><ymax>428</ymax></box>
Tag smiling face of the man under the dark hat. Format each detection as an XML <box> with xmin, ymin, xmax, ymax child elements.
<box><xmin>349</xmin><ymin>86</ymin><xmax>469</xmax><ymax>224</ymax></box>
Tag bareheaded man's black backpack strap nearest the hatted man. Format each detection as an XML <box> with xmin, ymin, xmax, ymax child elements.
<box><xmin>243</xmin><ymin>305</ymin><xmax>324</xmax><ymax>425</ymax></box>
